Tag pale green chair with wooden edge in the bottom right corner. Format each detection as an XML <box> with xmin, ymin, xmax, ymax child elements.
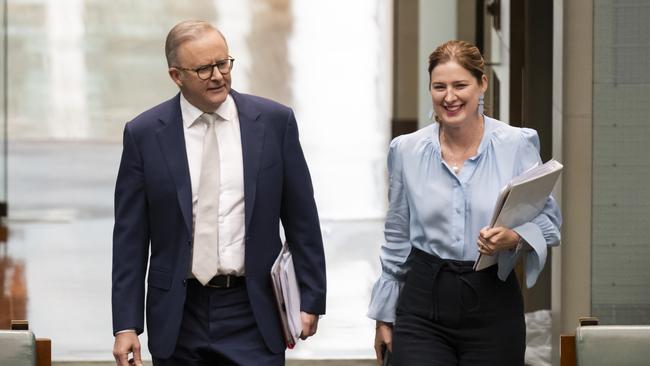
<box><xmin>560</xmin><ymin>318</ymin><xmax>650</xmax><ymax>366</ymax></box>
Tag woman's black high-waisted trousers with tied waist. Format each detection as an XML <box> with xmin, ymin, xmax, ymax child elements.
<box><xmin>392</xmin><ymin>248</ymin><xmax>526</xmax><ymax>366</ymax></box>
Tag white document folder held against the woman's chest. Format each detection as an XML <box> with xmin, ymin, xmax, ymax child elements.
<box><xmin>474</xmin><ymin>159</ymin><xmax>563</xmax><ymax>271</ymax></box>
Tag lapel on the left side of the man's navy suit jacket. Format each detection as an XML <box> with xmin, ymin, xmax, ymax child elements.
<box><xmin>156</xmin><ymin>94</ymin><xmax>192</xmax><ymax>233</ymax></box>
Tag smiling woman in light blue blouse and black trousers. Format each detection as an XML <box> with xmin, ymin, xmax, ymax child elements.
<box><xmin>369</xmin><ymin>41</ymin><xmax>561</xmax><ymax>366</ymax></box>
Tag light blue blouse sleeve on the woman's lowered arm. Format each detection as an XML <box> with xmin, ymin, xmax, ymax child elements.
<box><xmin>368</xmin><ymin>137</ymin><xmax>411</xmax><ymax>323</ymax></box>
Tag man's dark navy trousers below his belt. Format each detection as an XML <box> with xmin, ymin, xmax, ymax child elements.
<box><xmin>153</xmin><ymin>280</ymin><xmax>284</xmax><ymax>366</ymax></box>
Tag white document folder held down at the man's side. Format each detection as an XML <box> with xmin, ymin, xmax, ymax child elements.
<box><xmin>271</xmin><ymin>242</ymin><xmax>302</xmax><ymax>348</ymax></box>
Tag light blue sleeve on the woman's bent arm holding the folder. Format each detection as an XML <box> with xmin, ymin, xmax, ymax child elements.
<box><xmin>499</xmin><ymin>128</ymin><xmax>562</xmax><ymax>288</ymax></box>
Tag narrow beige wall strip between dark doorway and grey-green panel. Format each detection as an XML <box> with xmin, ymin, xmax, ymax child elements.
<box><xmin>553</xmin><ymin>0</ymin><xmax>593</xmax><ymax>365</ymax></box>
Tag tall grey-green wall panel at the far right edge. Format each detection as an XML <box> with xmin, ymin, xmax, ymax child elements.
<box><xmin>592</xmin><ymin>0</ymin><xmax>650</xmax><ymax>324</ymax></box>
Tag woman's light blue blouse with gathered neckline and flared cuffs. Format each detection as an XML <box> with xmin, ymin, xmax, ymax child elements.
<box><xmin>368</xmin><ymin>117</ymin><xmax>562</xmax><ymax>323</ymax></box>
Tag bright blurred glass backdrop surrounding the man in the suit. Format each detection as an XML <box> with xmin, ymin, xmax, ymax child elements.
<box><xmin>8</xmin><ymin>0</ymin><xmax>392</xmax><ymax>360</ymax></box>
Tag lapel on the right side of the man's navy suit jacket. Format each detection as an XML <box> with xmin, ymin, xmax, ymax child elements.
<box><xmin>230</xmin><ymin>90</ymin><xmax>264</xmax><ymax>228</ymax></box>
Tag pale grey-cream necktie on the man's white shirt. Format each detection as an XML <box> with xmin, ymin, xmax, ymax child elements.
<box><xmin>192</xmin><ymin>113</ymin><xmax>220</xmax><ymax>285</ymax></box>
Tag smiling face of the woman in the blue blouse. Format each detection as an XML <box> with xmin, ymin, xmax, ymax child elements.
<box><xmin>430</xmin><ymin>61</ymin><xmax>487</xmax><ymax>127</ymax></box>
